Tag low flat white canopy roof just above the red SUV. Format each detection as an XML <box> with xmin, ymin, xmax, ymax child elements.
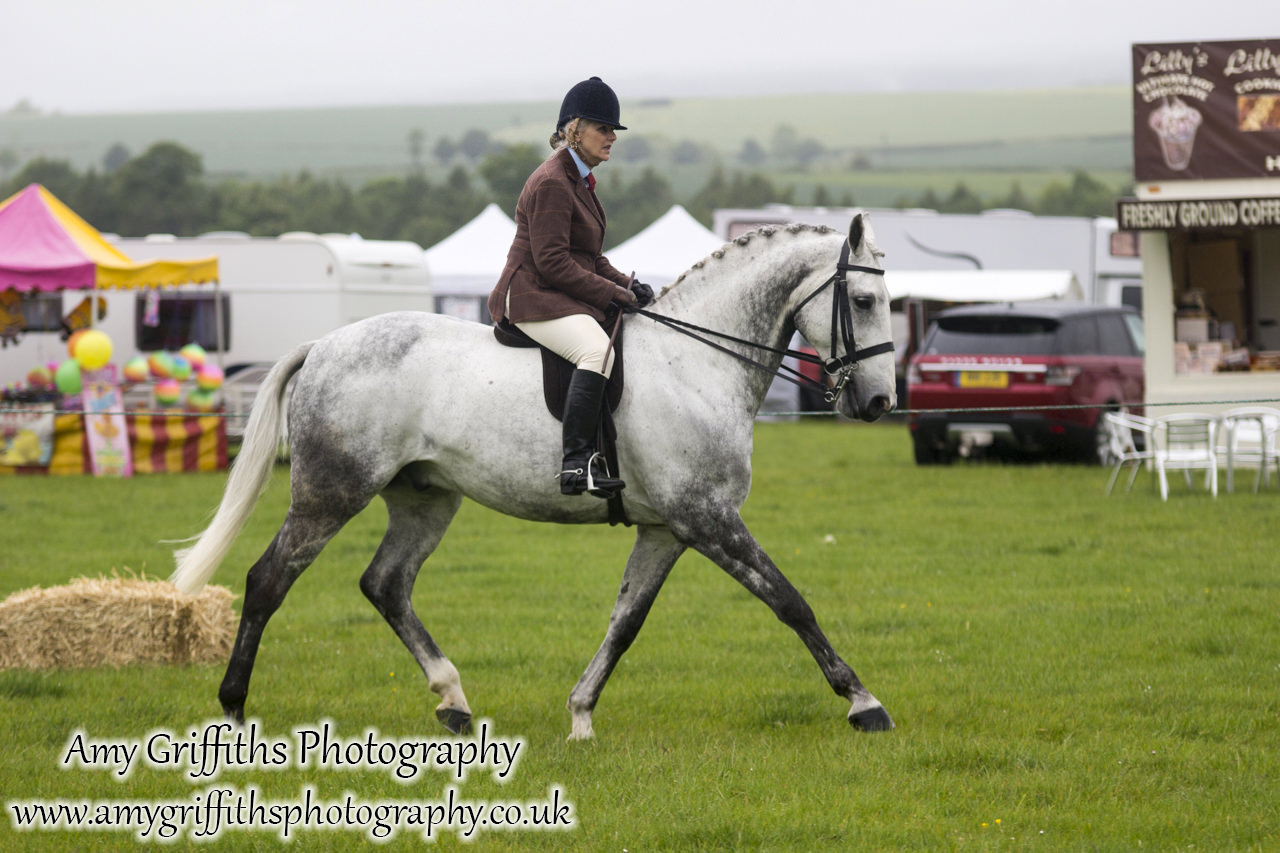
<box><xmin>884</xmin><ymin>269</ymin><xmax>1084</xmax><ymax>302</ymax></box>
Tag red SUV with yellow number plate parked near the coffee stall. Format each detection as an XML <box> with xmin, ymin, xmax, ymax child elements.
<box><xmin>908</xmin><ymin>302</ymin><xmax>1143</xmax><ymax>465</ymax></box>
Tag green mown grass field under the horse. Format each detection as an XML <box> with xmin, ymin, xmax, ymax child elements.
<box><xmin>0</xmin><ymin>419</ymin><xmax>1280</xmax><ymax>850</ymax></box>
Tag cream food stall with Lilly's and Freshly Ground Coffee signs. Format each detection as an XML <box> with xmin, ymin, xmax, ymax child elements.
<box><xmin>1116</xmin><ymin>38</ymin><xmax>1280</xmax><ymax>414</ymax></box>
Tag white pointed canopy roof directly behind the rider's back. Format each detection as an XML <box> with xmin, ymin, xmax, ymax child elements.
<box><xmin>424</xmin><ymin>204</ymin><xmax>516</xmax><ymax>296</ymax></box>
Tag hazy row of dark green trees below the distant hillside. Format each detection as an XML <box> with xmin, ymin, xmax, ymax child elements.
<box><xmin>0</xmin><ymin>137</ymin><xmax>1119</xmax><ymax>247</ymax></box>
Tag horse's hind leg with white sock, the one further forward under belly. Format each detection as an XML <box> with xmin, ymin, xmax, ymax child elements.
<box><xmin>360</xmin><ymin>484</ymin><xmax>471</xmax><ymax>734</ymax></box>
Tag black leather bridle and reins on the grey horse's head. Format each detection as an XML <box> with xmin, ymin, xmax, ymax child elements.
<box><xmin>625</xmin><ymin>241</ymin><xmax>893</xmax><ymax>403</ymax></box>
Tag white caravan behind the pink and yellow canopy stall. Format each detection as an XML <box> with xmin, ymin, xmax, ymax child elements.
<box><xmin>0</xmin><ymin>232</ymin><xmax>434</xmax><ymax>384</ymax></box>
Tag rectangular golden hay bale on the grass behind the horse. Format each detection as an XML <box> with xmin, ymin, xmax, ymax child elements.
<box><xmin>0</xmin><ymin>576</ymin><xmax>236</xmax><ymax>670</ymax></box>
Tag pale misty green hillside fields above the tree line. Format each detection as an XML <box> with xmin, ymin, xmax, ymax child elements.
<box><xmin>0</xmin><ymin>87</ymin><xmax>1132</xmax><ymax>184</ymax></box>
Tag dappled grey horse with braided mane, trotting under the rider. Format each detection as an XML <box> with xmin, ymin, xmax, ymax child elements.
<box><xmin>170</xmin><ymin>211</ymin><xmax>896</xmax><ymax>739</ymax></box>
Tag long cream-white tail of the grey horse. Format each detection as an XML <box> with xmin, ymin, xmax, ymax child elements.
<box><xmin>169</xmin><ymin>343</ymin><xmax>312</xmax><ymax>593</ymax></box>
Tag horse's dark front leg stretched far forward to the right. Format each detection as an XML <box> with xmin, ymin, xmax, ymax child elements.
<box><xmin>677</xmin><ymin>508</ymin><xmax>893</xmax><ymax>731</ymax></box>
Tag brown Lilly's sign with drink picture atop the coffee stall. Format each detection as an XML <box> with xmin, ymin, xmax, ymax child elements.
<box><xmin>1133</xmin><ymin>38</ymin><xmax>1280</xmax><ymax>181</ymax></box>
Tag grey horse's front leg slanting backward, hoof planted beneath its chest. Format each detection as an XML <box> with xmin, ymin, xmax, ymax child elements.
<box><xmin>568</xmin><ymin>526</ymin><xmax>685</xmax><ymax>740</ymax></box>
